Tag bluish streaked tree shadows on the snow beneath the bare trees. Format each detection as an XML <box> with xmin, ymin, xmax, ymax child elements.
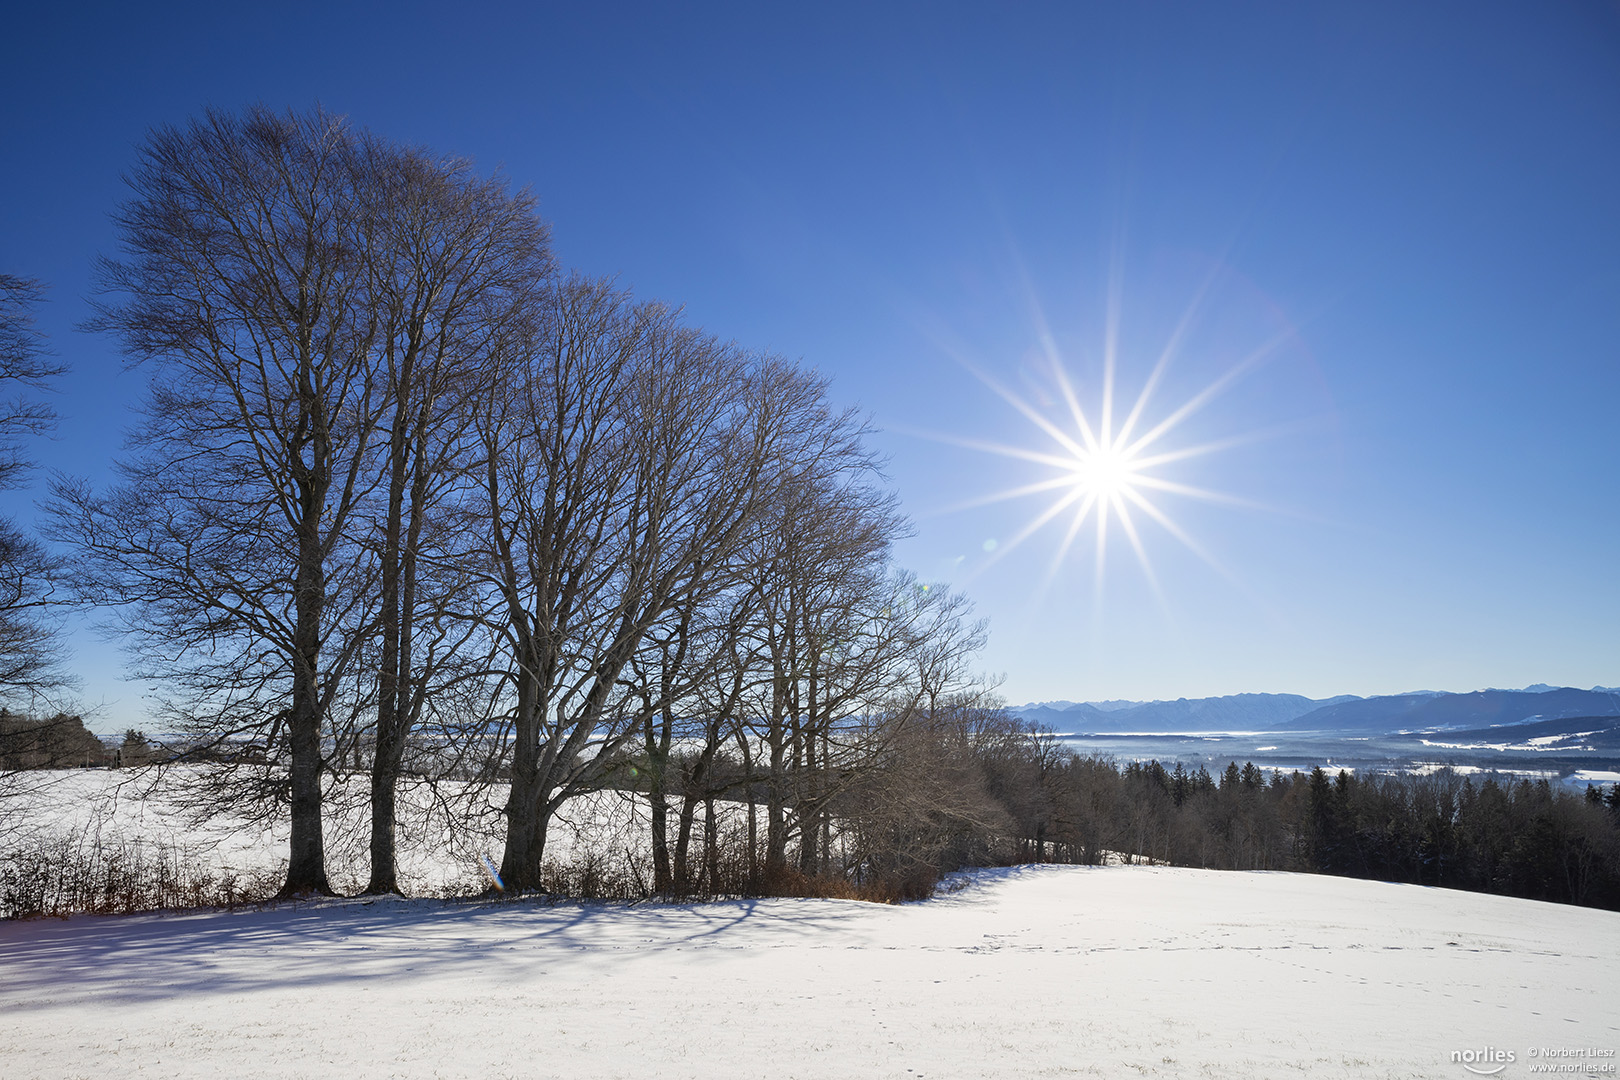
<box><xmin>0</xmin><ymin>899</ymin><xmax>896</xmax><ymax>1010</ymax></box>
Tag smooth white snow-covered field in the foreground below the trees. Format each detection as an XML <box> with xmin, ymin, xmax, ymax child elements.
<box><xmin>0</xmin><ymin>866</ymin><xmax>1620</xmax><ymax>1080</ymax></box>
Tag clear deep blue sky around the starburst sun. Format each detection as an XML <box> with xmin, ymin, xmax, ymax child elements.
<box><xmin>0</xmin><ymin>2</ymin><xmax>1620</xmax><ymax>721</ymax></box>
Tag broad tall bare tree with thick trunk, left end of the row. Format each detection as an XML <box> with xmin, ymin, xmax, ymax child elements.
<box><xmin>53</xmin><ymin>107</ymin><xmax>384</xmax><ymax>892</ymax></box>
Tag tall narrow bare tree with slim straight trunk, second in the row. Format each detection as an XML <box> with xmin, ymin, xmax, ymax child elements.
<box><xmin>358</xmin><ymin>136</ymin><xmax>551</xmax><ymax>894</ymax></box>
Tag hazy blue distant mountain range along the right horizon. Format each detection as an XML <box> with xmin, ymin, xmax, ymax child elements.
<box><xmin>1011</xmin><ymin>683</ymin><xmax>1620</xmax><ymax>735</ymax></box>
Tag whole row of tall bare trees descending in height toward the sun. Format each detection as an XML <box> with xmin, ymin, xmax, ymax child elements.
<box><xmin>38</xmin><ymin>108</ymin><xmax>982</xmax><ymax>894</ymax></box>
